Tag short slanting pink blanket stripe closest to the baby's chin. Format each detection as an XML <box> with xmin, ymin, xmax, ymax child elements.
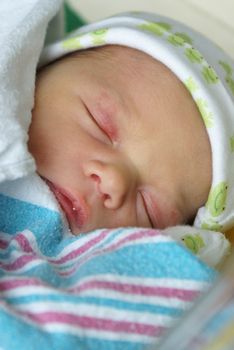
<box><xmin>50</xmin><ymin>230</ymin><xmax>111</xmax><ymax>264</ymax></box>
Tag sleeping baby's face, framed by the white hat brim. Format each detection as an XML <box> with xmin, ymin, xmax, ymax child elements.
<box><xmin>29</xmin><ymin>46</ymin><xmax>211</xmax><ymax>234</ymax></box>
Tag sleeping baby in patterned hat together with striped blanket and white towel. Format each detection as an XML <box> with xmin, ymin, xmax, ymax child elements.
<box><xmin>0</xmin><ymin>7</ymin><xmax>234</xmax><ymax>350</ymax></box>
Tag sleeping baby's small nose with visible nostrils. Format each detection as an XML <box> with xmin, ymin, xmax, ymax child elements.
<box><xmin>86</xmin><ymin>161</ymin><xmax>134</xmax><ymax>209</ymax></box>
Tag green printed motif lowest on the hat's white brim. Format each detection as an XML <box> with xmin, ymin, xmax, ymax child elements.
<box><xmin>206</xmin><ymin>181</ymin><xmax>228</xmax><ymax>217</ymax></box>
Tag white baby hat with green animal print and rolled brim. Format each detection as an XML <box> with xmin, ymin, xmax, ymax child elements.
<box><xmin>40</xmin><ymin>12</ymin><xmax>234</xmax><ymax>231</ymax></box>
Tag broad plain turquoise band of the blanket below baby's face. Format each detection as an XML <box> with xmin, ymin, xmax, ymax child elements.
<box><xmin>68</xmin><ymin>242</ymin><xmax>216</xmax><ymax>281</ymax></box>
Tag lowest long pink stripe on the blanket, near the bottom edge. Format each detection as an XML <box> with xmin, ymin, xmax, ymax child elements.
<box><xmin>22</xmin><ymin>312</ymin><xmax>165</xmax><ymax>336</ymax></box>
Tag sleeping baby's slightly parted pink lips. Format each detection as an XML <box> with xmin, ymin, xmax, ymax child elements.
<box><xmin>46</xmin><ymin>179</ymin><xmax>88</xmax><ymax>230</ymax></box>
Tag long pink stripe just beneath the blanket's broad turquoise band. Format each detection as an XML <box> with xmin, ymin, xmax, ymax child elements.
<box><xmin>71</xmin><ymin>281</ymin><xmax>199</xmax><ymax>301</ymax></box>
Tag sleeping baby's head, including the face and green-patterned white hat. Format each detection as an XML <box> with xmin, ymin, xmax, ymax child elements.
<box><xmin>28</xmin><ymin>13</ymin><xmax>234</xmax><ymax>243</ymax></box>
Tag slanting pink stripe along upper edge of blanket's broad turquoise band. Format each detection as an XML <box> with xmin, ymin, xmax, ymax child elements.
<box><xmin>59</xmin><ymin>229</ymin><xmax>160</xmax><ymax>276</ymax></box>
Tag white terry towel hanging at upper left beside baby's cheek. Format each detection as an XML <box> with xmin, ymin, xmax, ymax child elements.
<box><xmin>0</xmin><ymin>0</ymin><xmax>62</xmax><ymax>182</ymax></box>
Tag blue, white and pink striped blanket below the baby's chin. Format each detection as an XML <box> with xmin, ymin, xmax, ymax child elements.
<box><xmin>0</xmin><ymin>217</ymin><xmax>215</xmax><ymax>350</ymax></box>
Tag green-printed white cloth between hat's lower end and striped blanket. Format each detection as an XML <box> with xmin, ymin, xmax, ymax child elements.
<box><xmin>162</xmin><ymin>225</ymin><xmax>231</xmax><ymax>268</ymax></box>
